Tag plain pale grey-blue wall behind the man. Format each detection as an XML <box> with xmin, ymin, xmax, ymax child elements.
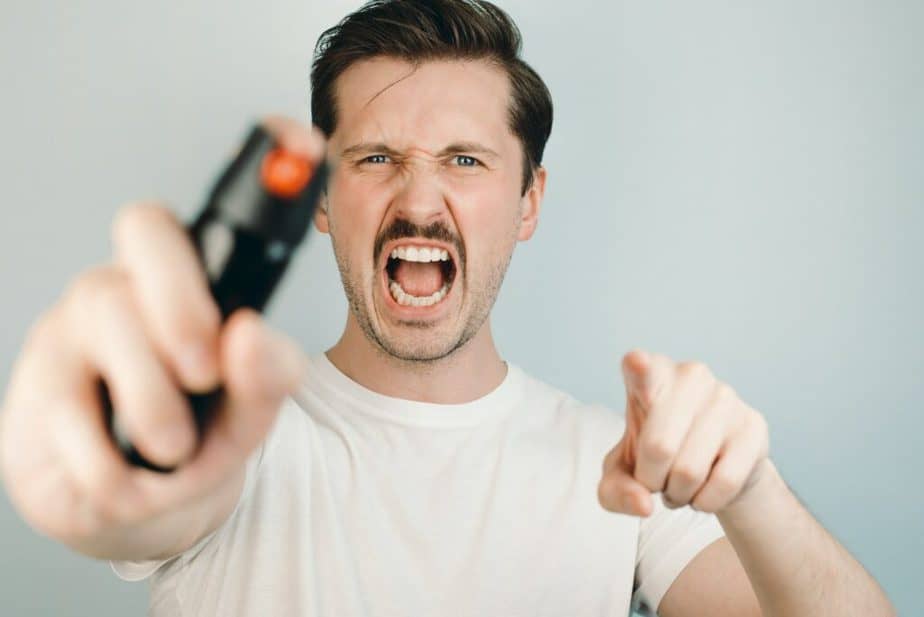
<box><xmin>0</xmin><ymin>0</ymin><xmax>924</xmax><ymax>616</ymax></box>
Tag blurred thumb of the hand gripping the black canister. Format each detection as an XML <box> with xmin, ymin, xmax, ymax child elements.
<box><xmin>215</xmin><ymin>309</ymin><xmax>307</xmax><ymax>455</ymax></box>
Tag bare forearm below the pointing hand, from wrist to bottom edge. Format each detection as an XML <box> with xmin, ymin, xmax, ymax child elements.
<box><xmin>718</xmin><ymin>459</ymin><xmax>896</xmax><ymax>617</ymax></box>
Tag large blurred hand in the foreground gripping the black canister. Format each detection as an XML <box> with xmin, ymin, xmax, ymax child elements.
<box><xmin>0</xmin><ymin>118</ymin><xmax>323</xmax><ymax>559</ymax></box>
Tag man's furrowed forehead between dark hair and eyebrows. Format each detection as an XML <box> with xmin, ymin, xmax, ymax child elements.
<box><xmin>331</xmin><ymin>57</ymin><xmax>515</xmax><ymax>150</ymax></box>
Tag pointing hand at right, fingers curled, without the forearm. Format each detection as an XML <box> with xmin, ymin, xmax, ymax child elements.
<box><xmin>597</xmin><ymin>350</ymin><xmax>769</xmax><ymax>516</ymax></box>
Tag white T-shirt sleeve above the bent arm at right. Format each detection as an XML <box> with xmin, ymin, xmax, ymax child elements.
<box><xmin>632</xmin><ymin>493</ymin><xmax>725</xmax><ymax>615</ymax></box>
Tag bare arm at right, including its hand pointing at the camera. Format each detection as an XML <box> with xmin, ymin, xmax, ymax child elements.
<box><xmin>598</xmin><ymin>351</ymin><xmax>895</xmax><ymax>617</ymax></box>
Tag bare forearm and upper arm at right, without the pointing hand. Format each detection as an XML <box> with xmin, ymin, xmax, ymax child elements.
<box><xmin>660</xmin><ymin>459</ymin><xmax>896</xmax><ymax>617</ymax></box>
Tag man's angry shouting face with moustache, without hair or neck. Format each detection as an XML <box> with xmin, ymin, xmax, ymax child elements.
<box><xmin>316</xmin><ymin>58</ymin><xmax>545</xmax><ymax>361</ymax></box>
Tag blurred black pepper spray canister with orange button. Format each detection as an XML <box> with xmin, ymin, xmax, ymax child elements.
<box><xmin>99</xmin><ymin>124</ymin><xmax>328</xmax><ymax>472</ymax></box>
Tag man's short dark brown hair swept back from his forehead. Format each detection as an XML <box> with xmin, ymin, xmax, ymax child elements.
<box><xmin>311</xmin><ymin>0</ymin><xmax>552</xmax><ymax>194</ymax></box>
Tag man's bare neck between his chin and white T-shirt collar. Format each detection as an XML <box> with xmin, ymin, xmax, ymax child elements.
<box><xmin>326</xmin><ymin>313</ymin><xmax>507</xmax><ymax>404</ymax></box>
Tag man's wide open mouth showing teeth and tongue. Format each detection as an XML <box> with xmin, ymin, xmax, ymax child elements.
<box><xmin>384</xmin><ymin>243</ymin><xmax>456</xmax><ymax>307</ymax></box>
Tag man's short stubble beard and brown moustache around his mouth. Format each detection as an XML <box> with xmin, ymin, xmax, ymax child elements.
<box><xmin>330</xmin><ymin>219</ymin><xmax>513</xmax><ymax>365</ymax></box>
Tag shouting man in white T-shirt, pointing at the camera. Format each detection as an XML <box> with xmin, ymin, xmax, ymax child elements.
<box><xmin>0</xmin><ymin>0</ymin><xmax>894</xmax><ymax>616</ymax></box>
